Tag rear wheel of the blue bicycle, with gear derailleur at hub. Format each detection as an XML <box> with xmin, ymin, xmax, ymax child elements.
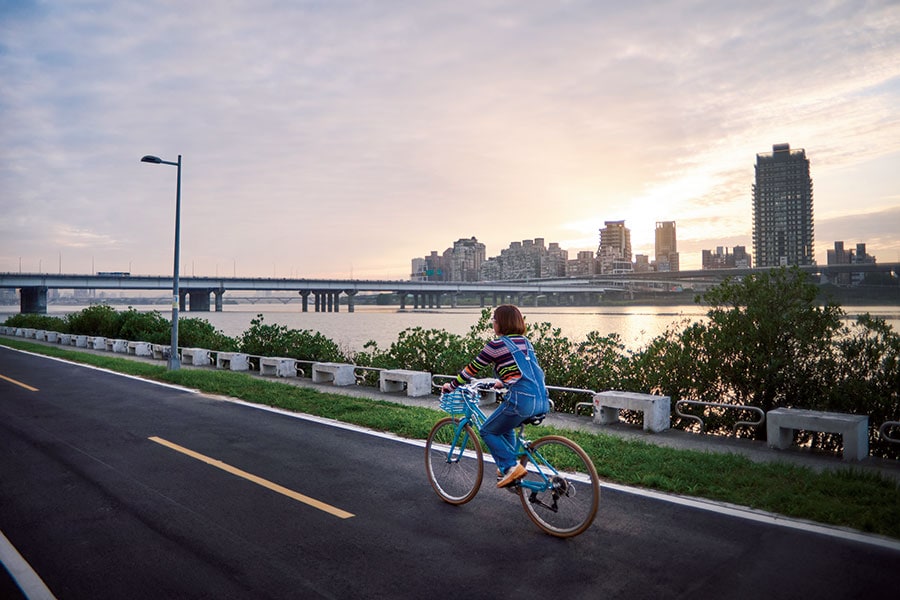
<box><xmin>519</xmin><ymin>435</ymin><xmax>600</xmax><ymax>538</ymax></box>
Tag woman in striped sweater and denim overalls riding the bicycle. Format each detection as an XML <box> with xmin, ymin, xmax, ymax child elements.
<box><xmin>442</xmin><ymin>304</ymin><xmax>550</xmax><ymax>488</ymax></box>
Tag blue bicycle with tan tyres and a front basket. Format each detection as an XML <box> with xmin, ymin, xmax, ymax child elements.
<box><xmin>425</xmin><ymin>379</ymin><xmax>600</xmax><ymax>538</ymax></box>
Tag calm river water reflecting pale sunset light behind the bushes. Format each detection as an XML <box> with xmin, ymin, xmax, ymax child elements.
<box><xmin>22</xmin><ymin>303</ymin><xmax>900</xmax><ymax>351</ymax></box>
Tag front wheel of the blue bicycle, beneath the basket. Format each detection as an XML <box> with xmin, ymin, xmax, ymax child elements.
<box><xmin>425</xmin><ymin>417</ymin><xmax>484</xmax><ymax>504</ymax></box>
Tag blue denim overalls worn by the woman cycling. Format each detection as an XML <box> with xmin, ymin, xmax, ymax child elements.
<box><xmin>481</xmin><ymin>336</ymin><xmax>550</xmax><ymax>472</ymax></box>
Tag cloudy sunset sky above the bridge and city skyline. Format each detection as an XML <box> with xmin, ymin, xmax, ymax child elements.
<box><xmin>0</xmin><ymin>0</ymin><xmax>900</xmax><ymax>279</ymax></box>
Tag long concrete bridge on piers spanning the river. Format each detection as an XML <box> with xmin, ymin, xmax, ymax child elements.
<box><xmin>0</xmin><ymin>263</ymin><xmax>900</xmax><ymax>313</ymax></box>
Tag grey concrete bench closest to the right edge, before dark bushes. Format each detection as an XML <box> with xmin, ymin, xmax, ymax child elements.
<box><xmin>766</xmin><ymin>408</ymin><xmax>869</xmax><ymax>460</ymax></box>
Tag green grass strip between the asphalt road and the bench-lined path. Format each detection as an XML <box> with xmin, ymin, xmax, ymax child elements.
<box><xmin>0</xmin><ymin>339</ymin><xmax>900</xmax><ymax>539</ymax></box>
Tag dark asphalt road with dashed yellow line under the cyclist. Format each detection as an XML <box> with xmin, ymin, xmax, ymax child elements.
<box><xmin>0</xmin><ymin>347</ymin><xmax>900</xmax><ymax>600</ymax></box>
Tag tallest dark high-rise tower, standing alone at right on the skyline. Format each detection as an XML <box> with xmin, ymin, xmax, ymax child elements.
<box><xmin>753</xmin><ymin>144</ymin><xmax>815</xmax><ymax>267</ymax></box>
